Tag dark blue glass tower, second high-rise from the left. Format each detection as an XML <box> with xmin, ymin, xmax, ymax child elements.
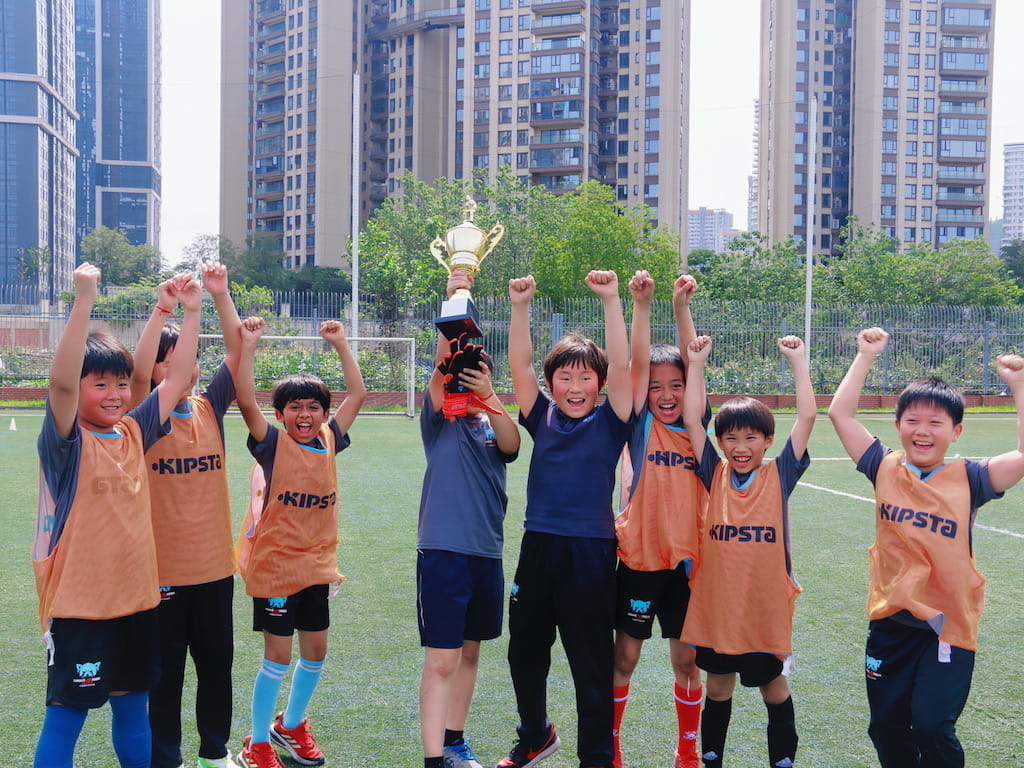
<box><xmin>74</xmin><ymin>0</ymin><xmax>161</xmax><ymax>248</ymax></box>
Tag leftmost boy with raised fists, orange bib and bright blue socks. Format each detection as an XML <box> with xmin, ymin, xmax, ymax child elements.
<box><xmin>33</xmin><ymin>263</ymin><xmax>202</xmax><ymax>768</ymax></box>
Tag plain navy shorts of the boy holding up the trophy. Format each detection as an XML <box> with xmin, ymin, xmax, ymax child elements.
<box><xmin>416</xmin><ymin>549</ymin><xmax>505</xmax><ymax>648</ymax></box>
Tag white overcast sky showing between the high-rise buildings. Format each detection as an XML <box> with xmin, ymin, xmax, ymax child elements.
<box><xmin>161</xmin><ymin>0</ymin><xmax>1024</xmax><ymax>264</ymax></box>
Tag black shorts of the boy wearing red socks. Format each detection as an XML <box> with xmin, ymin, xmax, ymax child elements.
<box><xmin>615</xmin><ymin>562</ymin><xmax>690</xmax><ymax>640</ymax></box>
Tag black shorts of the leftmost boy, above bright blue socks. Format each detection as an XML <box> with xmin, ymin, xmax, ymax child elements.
<box><xmin>46</xmin><ymin>608</ymin><xmax>160</xmax><ymax>710</ymax></box>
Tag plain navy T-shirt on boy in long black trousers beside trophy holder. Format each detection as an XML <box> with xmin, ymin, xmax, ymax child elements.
<box><xmin>519</xmin><ymin>392</ymin><xmax>630</xmax><ymax>539</ymax></box>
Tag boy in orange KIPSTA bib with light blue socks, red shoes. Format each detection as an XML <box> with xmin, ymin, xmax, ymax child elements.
<box><xmin>236</xmin><ymin>317</ymin><xmax>367</xmax><ymax>768</ymax></box>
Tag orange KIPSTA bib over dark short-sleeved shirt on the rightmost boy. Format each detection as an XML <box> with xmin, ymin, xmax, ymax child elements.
<box><xmin>857</xmin><ymin>438</ymin><xmax>1002</xmax><ymax>650</ymax></box>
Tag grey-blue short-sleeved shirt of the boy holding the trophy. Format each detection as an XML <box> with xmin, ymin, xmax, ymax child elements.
<box><xmin>417</xmin><ymin>391</ymin><xmax>518</xmax><ymax>558</ymax></box>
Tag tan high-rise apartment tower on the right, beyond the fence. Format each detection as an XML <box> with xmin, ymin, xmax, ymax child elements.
<box><xmin>759</xmin><ymin>0</ymin><xmax>994</xmax><ymax>253</ymax></box>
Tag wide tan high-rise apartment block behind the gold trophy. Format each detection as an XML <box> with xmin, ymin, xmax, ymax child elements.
<box><xmin>221</xmin><ymin>0</ymin><xmax>689</xmax><ymax>266</ymax></box>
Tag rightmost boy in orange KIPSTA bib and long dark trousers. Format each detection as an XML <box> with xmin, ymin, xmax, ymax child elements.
<box><xmin>828</xmin><ymin>328</ymin><xmax>1024</xmax><ymax>768</ymax></box>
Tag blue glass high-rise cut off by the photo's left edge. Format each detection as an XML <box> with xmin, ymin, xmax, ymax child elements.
<box><xmin>0</xmin><ymin>0</ymin><xmax>78</xmax><ymax>293</ymax></box>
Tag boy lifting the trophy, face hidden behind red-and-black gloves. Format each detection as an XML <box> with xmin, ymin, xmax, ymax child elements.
<box><xmin>416</xmin><ymin>271</ymin><xmax>519</xmax><ymax>768</ymax></box>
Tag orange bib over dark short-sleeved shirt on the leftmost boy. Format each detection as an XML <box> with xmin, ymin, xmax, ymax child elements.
<box><xmin>33</xmin><ymin>392</ymin><xmax>166</xmax><ymax>631</ymax></box>
